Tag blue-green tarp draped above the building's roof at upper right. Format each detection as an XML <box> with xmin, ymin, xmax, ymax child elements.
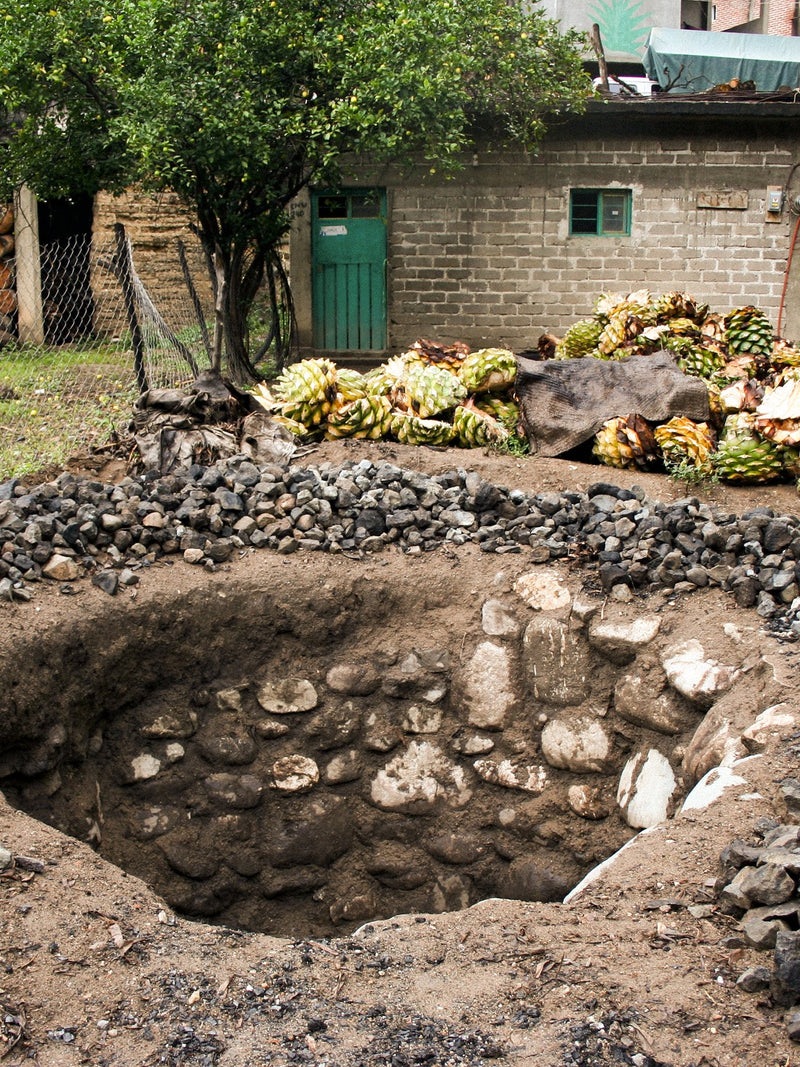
<box><xmin>642</xmin><ymin>29</ymin><xmax>800</xmax><ymax>93</ymax></box>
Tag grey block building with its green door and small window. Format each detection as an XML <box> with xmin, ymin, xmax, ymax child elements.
<box><xmin>291</xmin><ymin>94</ymin><xmax>800</xmax><ymax>355</ymax></box>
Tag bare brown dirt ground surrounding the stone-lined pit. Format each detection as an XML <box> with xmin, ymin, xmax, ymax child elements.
<box><xmin>0</xmin><ymin>443</ymin><xmax>800</xmax><ymax>1067</ymax></box>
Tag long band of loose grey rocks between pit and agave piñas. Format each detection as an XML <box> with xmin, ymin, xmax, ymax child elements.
<box><xmin>0</xmin><ymin>457</ymin><xmax>800</xmax><ymax>639</ymax></box>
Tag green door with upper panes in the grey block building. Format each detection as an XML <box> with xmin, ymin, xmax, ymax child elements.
<box><xmin>311</xmin><ymin>189</ymin><xmax>386</xmax><ymax>352</ymax></box>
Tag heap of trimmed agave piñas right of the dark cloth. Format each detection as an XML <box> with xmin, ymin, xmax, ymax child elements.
<box><xmin>555</xmin><ymin>289</ymin><xmax>800</xmax><ymax>483</ymax></box>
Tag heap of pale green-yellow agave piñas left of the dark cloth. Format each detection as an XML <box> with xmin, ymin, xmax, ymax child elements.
<box><xmin>254</xmin><ymin>340</ymin><xmax>519</xmax><ymax>448</ymax></box>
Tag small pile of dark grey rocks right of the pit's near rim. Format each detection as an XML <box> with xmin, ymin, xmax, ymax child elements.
<box><xmin>717</xmin><ymin>779</ymin><xmax>800</xmax><ymax>1041</ymax></box>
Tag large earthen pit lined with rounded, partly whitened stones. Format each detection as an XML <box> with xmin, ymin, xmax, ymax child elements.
<box><xmin>0</xmin><ymin>561</ymin><xmax>774</xmax><ymax>936</ymax></box>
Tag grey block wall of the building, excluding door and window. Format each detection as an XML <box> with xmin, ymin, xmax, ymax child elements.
<box><xmin>292</xmin><ymin>100</ymin><xmax>800</xmax><ymax>351</ymax></box>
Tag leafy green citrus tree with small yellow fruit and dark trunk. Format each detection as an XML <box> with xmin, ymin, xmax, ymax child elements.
<box><xmin>0</xmin><ymin>0</ymin><xmax>588</xmax><ymax>381</ymax></box>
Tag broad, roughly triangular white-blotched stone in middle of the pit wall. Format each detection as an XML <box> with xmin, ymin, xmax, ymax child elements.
<box><xmin>370</xmin><ymin>740</ymin><xmax>473</xmax><ymax>814</ymax></box>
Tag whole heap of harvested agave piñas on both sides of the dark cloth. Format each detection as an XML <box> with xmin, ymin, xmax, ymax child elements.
<box><xmin>254</xmin><ymin>289</ymin><xmax>800</xmax><ymax>483</ymax></box>
